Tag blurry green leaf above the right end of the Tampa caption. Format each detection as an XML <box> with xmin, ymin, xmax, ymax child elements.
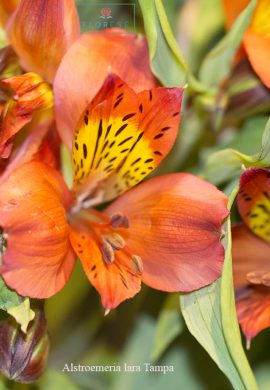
<box><xmin>151</xmin><ymin>294</ymin><xmax>184</xmax><ymax>360</ymax></box>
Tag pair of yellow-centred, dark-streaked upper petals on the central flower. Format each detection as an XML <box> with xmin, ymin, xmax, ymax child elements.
<box><xmin>73</xmin><ymin>75</ymin><xmax>183</xmax><ymax>207</ymax></box>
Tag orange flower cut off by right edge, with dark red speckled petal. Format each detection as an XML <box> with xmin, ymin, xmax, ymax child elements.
<box><xmin>233</xmin><ymin>168</ymin><xmax>270</xmax><ymax>346</ymax></box>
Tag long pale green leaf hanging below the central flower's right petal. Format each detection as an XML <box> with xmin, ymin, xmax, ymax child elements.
<box><xmin>180</xmin><ymin>188</ymin><xmax>258</xmax><ymax>390</ymax></box>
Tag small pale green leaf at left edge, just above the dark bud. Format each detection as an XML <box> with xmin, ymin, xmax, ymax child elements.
<box><xmin>0</xmin><ymin>278</ymin><xmax>35</xmax><ymax>333</ymax></box>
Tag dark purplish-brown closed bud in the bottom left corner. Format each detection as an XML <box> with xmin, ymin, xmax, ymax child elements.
<box><xmin>0</xmin><ymin>309</ymin><xmax>49</xmax><ymax>383</ymax></box>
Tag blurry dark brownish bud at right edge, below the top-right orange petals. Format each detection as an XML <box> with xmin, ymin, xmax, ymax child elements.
<box><xmin>225</xmin><ymin>60</ymin><xmax>270</xmax><ymax>124</ymax></box>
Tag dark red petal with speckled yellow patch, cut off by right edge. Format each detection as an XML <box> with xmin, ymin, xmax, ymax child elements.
<box><xmin>237</xmin><ymin>168</ymin><xmax>270</xmax><ymax>242</ymax></box>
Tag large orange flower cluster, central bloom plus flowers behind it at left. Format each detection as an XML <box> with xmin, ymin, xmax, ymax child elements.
<box><xmin>0</xmin><ymin>0</ymin><xmax>228</xmax><ymax>311</ymax></box>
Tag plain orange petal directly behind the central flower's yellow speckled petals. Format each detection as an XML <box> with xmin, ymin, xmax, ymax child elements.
<box><xmin>54</xmin><ymin>29</ymin><xmax>154</xmax><ymax>149</ymax></box>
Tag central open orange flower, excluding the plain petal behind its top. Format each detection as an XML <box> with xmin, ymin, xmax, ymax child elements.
<box><xmin>0</xmin><ymin>75</ymin><xmax>228</xmax><ymax>310</ymax></box>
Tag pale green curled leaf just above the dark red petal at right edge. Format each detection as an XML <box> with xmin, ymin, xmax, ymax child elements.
<box><xmin>203</xmin><ymin>115</ymin><xmax>270</xmax><ymax>185</ymax></box>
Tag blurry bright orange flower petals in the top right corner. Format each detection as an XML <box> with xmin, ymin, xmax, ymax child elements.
<box><xmin>223</xmin><ymin>0</ymin><xmax>270</xmax><ymax>88</ymax></box>
